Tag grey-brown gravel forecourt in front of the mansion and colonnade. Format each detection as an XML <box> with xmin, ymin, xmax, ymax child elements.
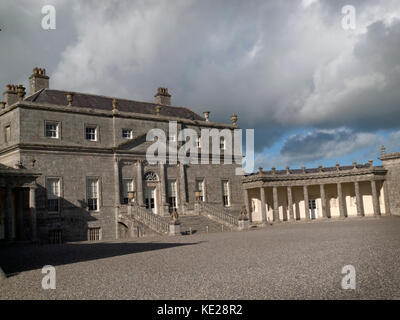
<box><xmin>0</xmin><ymin>217</ymin><xmax>400</xmax><ymax>299</ymax></box>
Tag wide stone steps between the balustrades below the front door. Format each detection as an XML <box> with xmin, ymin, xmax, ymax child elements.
<box><xmin>179</xmin><ymin>215</ymin><xmax>232</xmax><ymax>235</ymax></box>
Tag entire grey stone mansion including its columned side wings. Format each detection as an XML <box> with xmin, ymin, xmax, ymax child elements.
<box><xmin>0</xmin><ymin>68</ymin><xmax>400</xmax><ymax>243</ymax></box>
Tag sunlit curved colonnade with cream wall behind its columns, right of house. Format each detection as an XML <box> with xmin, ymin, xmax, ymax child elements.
<box><xmin>243</xmin><ymin>161</ymin><xmax>390</xmax><ymax>223</ymax></box>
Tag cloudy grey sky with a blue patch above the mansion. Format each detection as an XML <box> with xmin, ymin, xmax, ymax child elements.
<box><xmin>0</xmin><ymin>0</ymin><xmax>400</xmax><ymax>168</ymax></box>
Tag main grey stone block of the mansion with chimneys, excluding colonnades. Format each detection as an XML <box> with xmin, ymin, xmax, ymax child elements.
<box><xmin>0</xmin><ymin>68</ymin><xmax>243</xmax><ymax>242</ymax></box>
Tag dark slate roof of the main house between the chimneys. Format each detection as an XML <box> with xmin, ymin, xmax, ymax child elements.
<box><xmin>25</xmin><ymin>89</ymin><xmax>205</xmax><ymax>121</ymax></box>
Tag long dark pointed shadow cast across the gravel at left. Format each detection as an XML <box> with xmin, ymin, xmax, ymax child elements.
<box><xmin>0</xmin><ymin>242</ymin><xmax>200</xmax><ymax>277</ymax></box>
